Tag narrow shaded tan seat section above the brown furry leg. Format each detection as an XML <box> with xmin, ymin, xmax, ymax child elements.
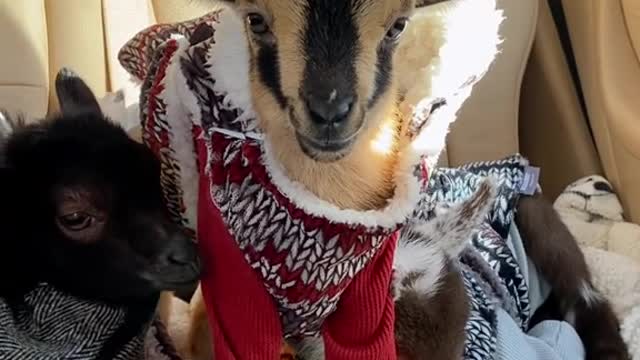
<box><xmin>520</xmin><ymin>0</ymin><xmax>608</xmax><ymax>199</ymax></box>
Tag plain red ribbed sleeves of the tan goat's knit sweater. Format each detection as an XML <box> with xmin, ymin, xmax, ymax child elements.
<box><xmin>192</xmin><ymin>134</ymin><xmax>397</xmax><ymax>360</ymax></box>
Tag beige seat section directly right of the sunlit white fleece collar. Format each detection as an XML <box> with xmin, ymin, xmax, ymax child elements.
<box><xmin>447</xmin><ymin>0</ymin><xmax>538</xmax><ymax>165</ymax></box>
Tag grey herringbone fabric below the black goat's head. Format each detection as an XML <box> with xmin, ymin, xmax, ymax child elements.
<box><xmin>0</xmin><ymin>284</ymin><xmax>180</xmax><ymax>360</ymax></box>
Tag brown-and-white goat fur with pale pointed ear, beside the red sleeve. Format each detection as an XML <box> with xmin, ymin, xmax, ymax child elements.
<box><xmin>394</xmin><ymin>180</ymin><xmax>497</xmax><ymax>360</ymax></box>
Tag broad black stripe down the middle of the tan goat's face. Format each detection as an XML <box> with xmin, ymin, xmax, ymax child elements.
<box><xmin>303</xmin><ymin>0</ymin><xmax>360</xmax><ymax>97</ymax></box>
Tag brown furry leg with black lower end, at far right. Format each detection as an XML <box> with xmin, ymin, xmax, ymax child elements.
<box><xmin>516</xmin><ymin>194</ymin><xmax>630</xmax><ymax>360</ymax></box>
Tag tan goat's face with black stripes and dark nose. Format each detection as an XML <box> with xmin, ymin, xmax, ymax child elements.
<box><xmin>218</xmin><ymin>0</ymin><xmax>448</xmax><ymax>161</ymax></box>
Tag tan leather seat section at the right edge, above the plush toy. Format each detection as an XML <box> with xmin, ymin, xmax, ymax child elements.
<box><xmin>562</xmin><ymin>0</ymin><xmax>640</xmax><ymax>222</ymax></box>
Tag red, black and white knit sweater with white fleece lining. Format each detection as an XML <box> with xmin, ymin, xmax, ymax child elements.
<box><xmin>120</xmin><ymin>13</ymin><xmax>426</xmax><ymax>360</ymax></box>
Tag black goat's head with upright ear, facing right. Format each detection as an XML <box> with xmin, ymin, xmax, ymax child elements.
<box><xmin>0</xmin><ymin>67</ymin><xmax>199</xmax><ymax>303</ymax></box>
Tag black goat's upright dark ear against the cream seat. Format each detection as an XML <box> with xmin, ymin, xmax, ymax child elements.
<box><xmin>56</xmin><ymin>68</ymin><xmax>102</xmax><ymax>116</ymax></box>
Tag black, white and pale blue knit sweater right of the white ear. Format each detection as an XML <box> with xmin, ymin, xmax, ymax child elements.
<box><xmin>428</xmin><ymin>155</ymin><xmax>532</xmax><ymax>360</ymax></box>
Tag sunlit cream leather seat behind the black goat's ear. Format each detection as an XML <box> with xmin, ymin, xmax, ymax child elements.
<box><xmin>0</xmin><ymin>0</ymin><xmax>212</xmax><ymax>118</ymax></box>
